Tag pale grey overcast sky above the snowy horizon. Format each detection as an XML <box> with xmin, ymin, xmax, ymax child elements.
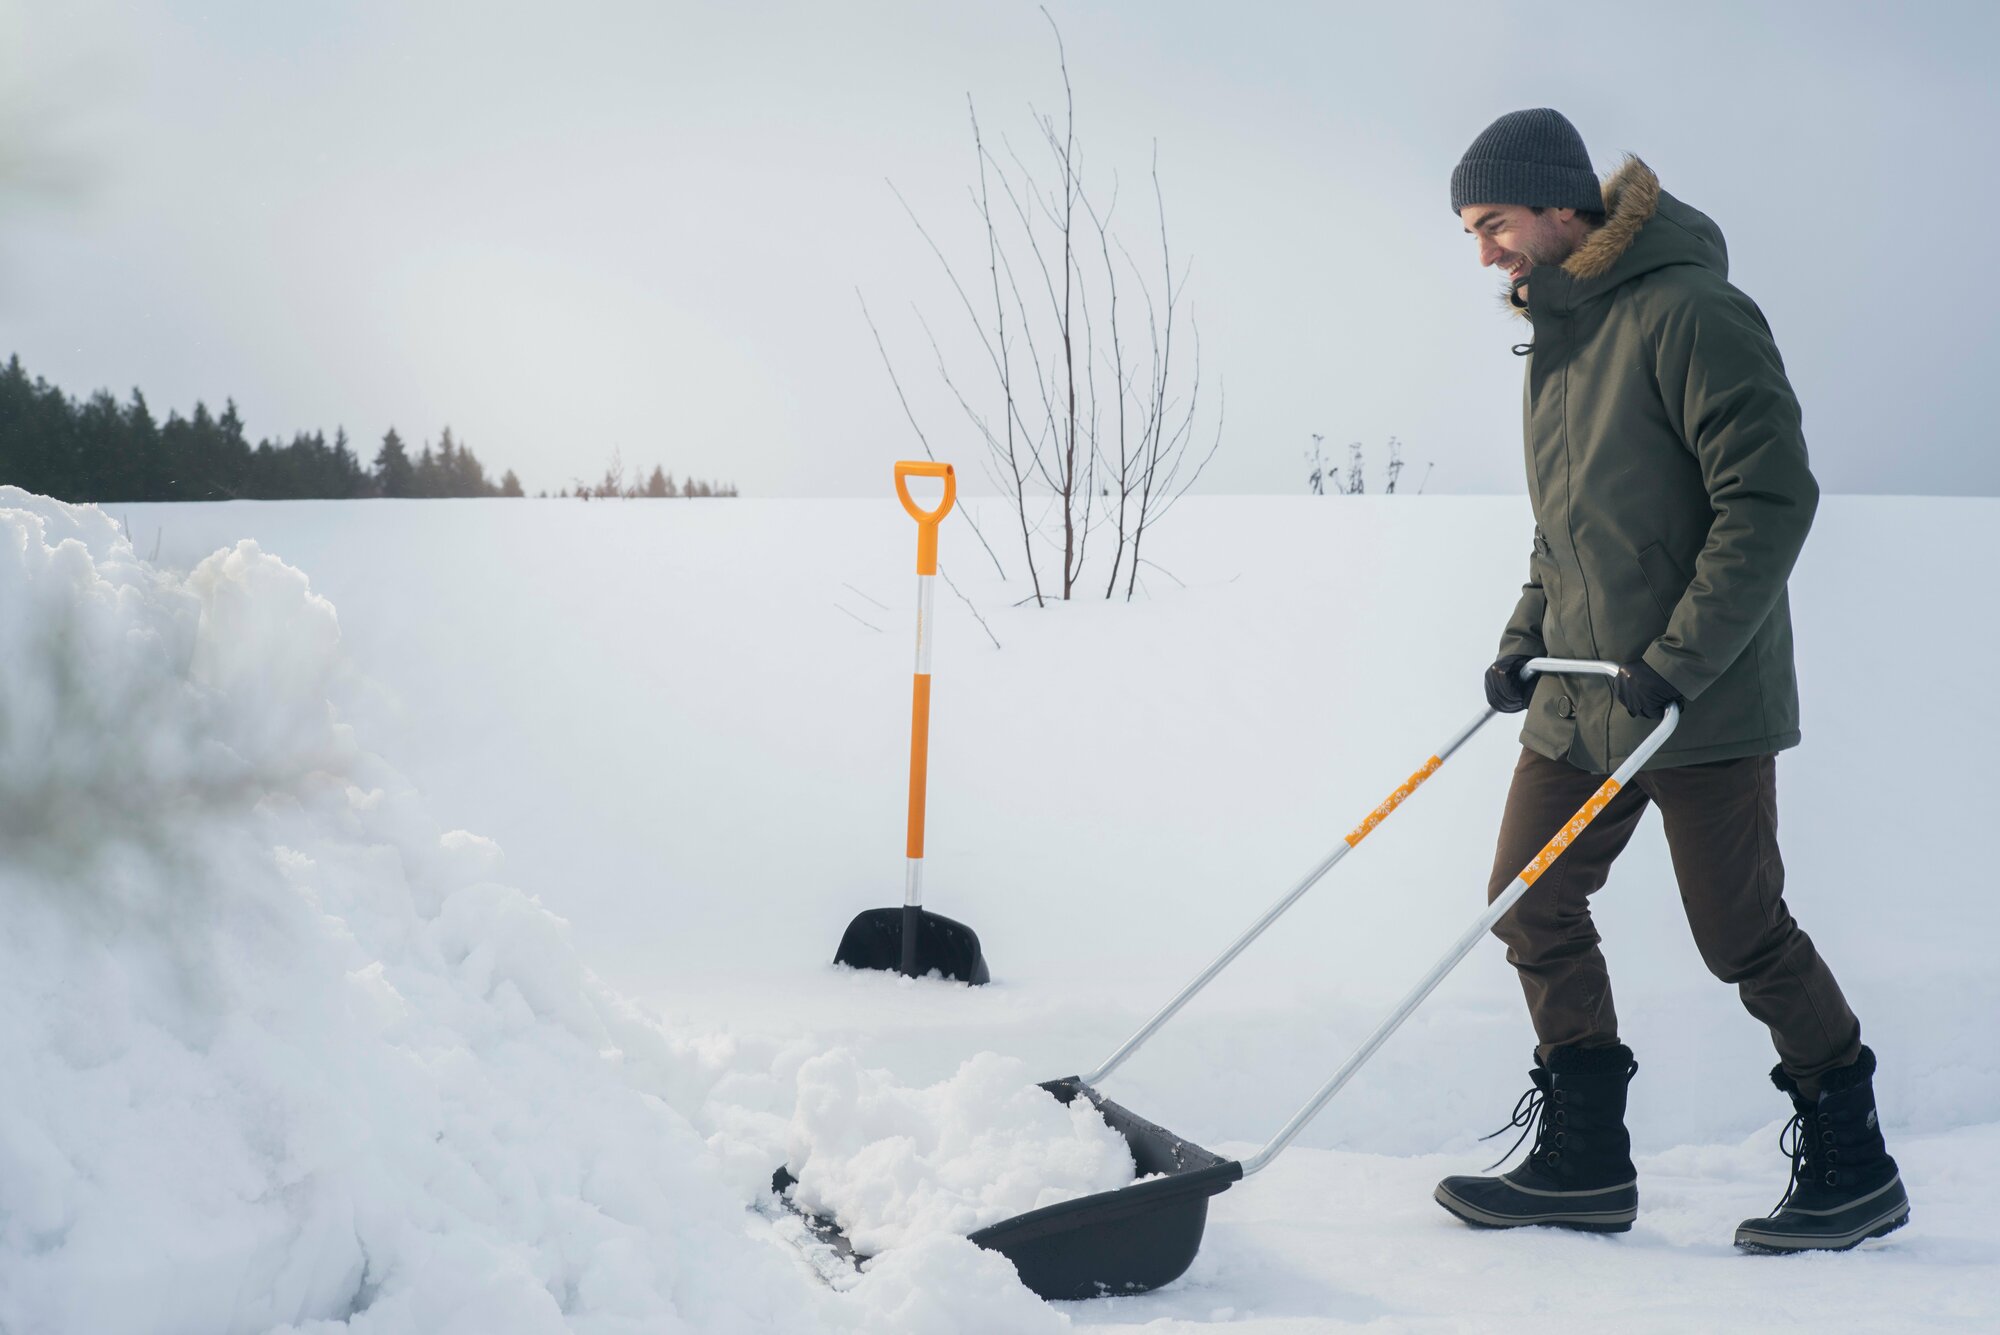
<box><xmin>0</xmin><ymin>0</ymin><xmax>2000</xmax><ymax>496</ymax></box>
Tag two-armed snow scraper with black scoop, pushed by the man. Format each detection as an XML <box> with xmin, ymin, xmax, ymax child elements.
<box><xmin>772</xmin><ymin>658</ymin><xmax>1680</xmax><ymax>1299</ymax></box>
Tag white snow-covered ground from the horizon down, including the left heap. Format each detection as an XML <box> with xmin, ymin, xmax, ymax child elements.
<box><xmin>0</xmin><ymin>492</ymin><xmax>2000</xmax><ymax>1335</ymax></box>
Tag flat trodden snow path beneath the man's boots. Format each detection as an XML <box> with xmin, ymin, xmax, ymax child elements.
<box><xmin>1062</xmin><ymin>1123</ymin><xmax>2000</xmax><ymax>1335</ymax></box>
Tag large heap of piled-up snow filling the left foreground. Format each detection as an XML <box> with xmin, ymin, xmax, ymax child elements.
<box><xmin>0</xmin><ymin>488</ymin><xmax>1054</xmax><ymax>1335</ymax></box>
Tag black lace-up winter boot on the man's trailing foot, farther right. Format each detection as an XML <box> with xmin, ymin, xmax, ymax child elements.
<box><xmin>1736</xmin><ymin>1047</ymin><xmax>1910</xmax><ymax>1251</ymax></box>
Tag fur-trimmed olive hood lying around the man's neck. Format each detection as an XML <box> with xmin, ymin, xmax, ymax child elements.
<box><xmin>1502</xmin><ymin>154</ymin><xmax>1730</xmax><ymax>316</ymax></box>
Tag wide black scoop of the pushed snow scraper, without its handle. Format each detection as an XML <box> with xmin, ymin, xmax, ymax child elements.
<box><xmin>770</xmin><ymin>1075</ymin><xmax>1244</xmax><ymax>1301</ymax></box>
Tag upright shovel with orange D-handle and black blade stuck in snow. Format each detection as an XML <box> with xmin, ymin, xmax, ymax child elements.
<box><xmin>834</xmin><ymin>460</ymin><xmax>992</xmax><ymax>983</ymax></box>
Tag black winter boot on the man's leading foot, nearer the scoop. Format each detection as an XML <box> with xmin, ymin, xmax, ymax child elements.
<box><xmin>1432</xmin><ymin>1043</ymin><xmax>1638</xmax><ymax>1233</ymax></box>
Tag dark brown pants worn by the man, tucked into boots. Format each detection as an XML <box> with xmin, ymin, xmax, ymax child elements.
<box><xmin>1486</xmin><ymin>749</ymin><xmax>1862</xmax><ymax>1095</ymax></box>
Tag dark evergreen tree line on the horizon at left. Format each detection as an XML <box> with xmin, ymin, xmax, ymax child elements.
<box><xmin>0</xmin><ymin>354</ymin><xmax>736</xmax><ymax>502</ymax></box>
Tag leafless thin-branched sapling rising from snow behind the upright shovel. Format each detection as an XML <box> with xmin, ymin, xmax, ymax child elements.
<box><xmin>862</xmin><ymin>10</ymin><xmax>1222</xmax><ymax>606</ymax></box>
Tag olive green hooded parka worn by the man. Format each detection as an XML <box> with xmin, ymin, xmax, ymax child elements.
<box><xmin>1500</xmin><ymin>158</ymin><xmax>1820</xmax><ymax>773</ymax></box>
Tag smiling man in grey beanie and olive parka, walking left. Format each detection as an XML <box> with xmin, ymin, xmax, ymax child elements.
<box><xmin>1436</xmin><ymin>108</ymin><xmax>1910</xmax><ymax>1251</ymax></box>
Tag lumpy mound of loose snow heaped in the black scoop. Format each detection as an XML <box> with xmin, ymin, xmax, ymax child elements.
<box><xmin>788</xmin><ymin>1049</ymin><xmax>1132</xmax><ymax>1253</ymax></box>
